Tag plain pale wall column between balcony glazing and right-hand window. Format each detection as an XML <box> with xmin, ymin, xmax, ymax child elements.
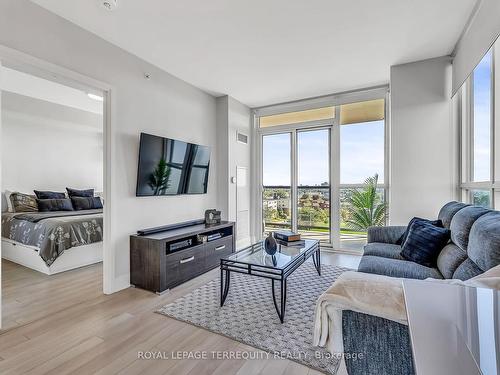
<box><xmin>389</xmin><ymin>57</ymin><xmax>457</xmax><ymax>225</ymax></box>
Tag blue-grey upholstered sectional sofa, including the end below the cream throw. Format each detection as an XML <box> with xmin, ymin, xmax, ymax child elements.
<box><xmin>342</xmin><ymin>202</ymin><xmax>500</xmax><ymax>375</ymax></box>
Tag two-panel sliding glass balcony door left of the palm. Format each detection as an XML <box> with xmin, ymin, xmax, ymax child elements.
<box><xmin>262</xmin><ymin>129</ymin><xmax>331</xmax><ymax>243</ymax></box>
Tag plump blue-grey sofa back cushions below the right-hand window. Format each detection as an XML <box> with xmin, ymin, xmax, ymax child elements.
<box><xmin>437</xmin><ymin>202</ymin><xmax>500</xmax><ymax>280</ymax></box>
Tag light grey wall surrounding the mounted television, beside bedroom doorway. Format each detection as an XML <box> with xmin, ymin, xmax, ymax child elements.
<box><xmin>0</xmin><ymin>0</ymin><xmax>218</xmax><ymax>293</ymax></box>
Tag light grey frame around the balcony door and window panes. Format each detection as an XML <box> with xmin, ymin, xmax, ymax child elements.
<box><xmin>253</xmin><ymin>85</ymin><xmax>390</xmax><ymax>252</ymax></box>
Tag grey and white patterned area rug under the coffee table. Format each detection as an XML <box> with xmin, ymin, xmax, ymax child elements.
<box><xmin>157</xmin><ymin>261</ymin><xmax>348</xmax><ymax>374</ymax></box>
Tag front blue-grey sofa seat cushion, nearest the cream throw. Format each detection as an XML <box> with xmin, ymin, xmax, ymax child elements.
<box><xmin>358</xmin><ymin>255</ymin><xmax>443</xmax><ymax>279</ymax></box>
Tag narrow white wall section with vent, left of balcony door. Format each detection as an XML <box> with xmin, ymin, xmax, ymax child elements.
<box><xmin>217</xmin><ymin>96</ymin><xmax>253</xmax><ymax>248</ymax></box>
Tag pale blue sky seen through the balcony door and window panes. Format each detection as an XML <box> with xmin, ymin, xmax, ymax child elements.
<box><xmin>263</xmin><ymin>121</ymin><xmax>384</xmax><ymax>186</ymax></box>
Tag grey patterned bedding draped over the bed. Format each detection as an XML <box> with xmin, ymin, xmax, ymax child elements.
<box><xmin>2</xmin><ymin>210</ymin><xmax>103</xmax><ymax>266</ymax></box>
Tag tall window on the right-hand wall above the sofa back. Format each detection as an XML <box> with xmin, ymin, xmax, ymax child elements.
<box><xmin>460</xmin><ymin>42</ymin><xmax>500</xmax><ymax>208</ymax></box>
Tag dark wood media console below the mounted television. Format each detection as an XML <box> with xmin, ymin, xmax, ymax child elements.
<box><xmin>130</xmin><ymin>221</ymin><xmax>235</xmax><ymax>294</ymax></box>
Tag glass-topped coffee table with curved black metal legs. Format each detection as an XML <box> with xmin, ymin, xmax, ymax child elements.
<box><xmin>220</xmin><ymin>240</ymin><xmax>321</xmax><ymax>323</ymax></box>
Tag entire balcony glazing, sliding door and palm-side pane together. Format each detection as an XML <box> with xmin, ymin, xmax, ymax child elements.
<box><xmin>259</xmin><ymin>94</ymin><xmax>388</xmax><ymax>251</ymax></box>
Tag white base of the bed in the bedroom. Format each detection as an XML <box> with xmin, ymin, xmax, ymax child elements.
<box><xmin>2</xmin><ymin>238</ymin><xmax>102</xmax><ymax>275</ymax></box>
